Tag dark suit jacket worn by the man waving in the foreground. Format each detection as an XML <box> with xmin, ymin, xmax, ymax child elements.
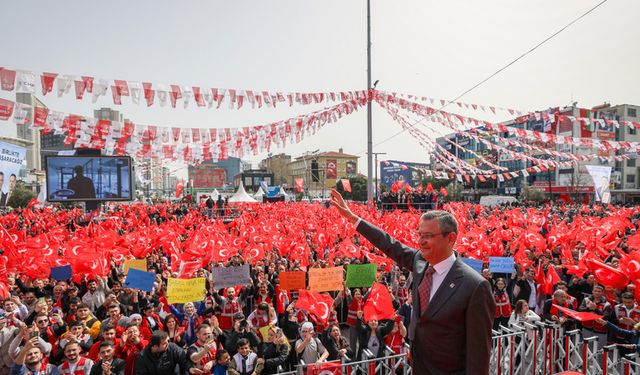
<box><xmin>356</xmin><ymin>220</ymin><xmax>496</xmax><ymax>375</ymax></box>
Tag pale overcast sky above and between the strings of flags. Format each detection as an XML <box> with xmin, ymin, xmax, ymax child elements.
<box><xmin>0</xmin><ymin>0</ymin><xmax>640</xmax><ymax>178</ymax></box>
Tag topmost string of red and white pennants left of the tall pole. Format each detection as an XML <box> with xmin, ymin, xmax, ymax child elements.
<box><xmin>0</xmin><ymin>67</ymin><xmax>368</xmax><ymax>109</ymax></box>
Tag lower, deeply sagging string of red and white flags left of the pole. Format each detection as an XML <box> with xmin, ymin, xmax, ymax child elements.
<box><xmin>0</xmin><ymin>98</ymin><xmax>367</xmax><ymax>165</ymax></box>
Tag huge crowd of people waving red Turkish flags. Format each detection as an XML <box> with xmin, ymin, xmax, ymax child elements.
<box><xmin>0</xmin><ymin>198</ymin><xmax>640</xmax><ymax>375</ymax></box>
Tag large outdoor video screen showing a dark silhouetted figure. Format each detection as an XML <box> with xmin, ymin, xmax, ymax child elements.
<box><xmin>45</xmin><ymin>155</ymin><xmax>133</xmax><ymax>202</ymax></box>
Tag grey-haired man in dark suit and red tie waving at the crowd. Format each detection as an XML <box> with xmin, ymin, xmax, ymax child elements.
<box><xmin>331</xmin><ymin>189</ymin><xmax>496</xmax><ymax>375</ymax></box>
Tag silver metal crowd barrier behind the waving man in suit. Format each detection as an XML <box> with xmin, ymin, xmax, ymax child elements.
<box><xmin>280</xmin><ymin>322</ymin><xmax>640</xmax><ymax>375</ymax></box>
